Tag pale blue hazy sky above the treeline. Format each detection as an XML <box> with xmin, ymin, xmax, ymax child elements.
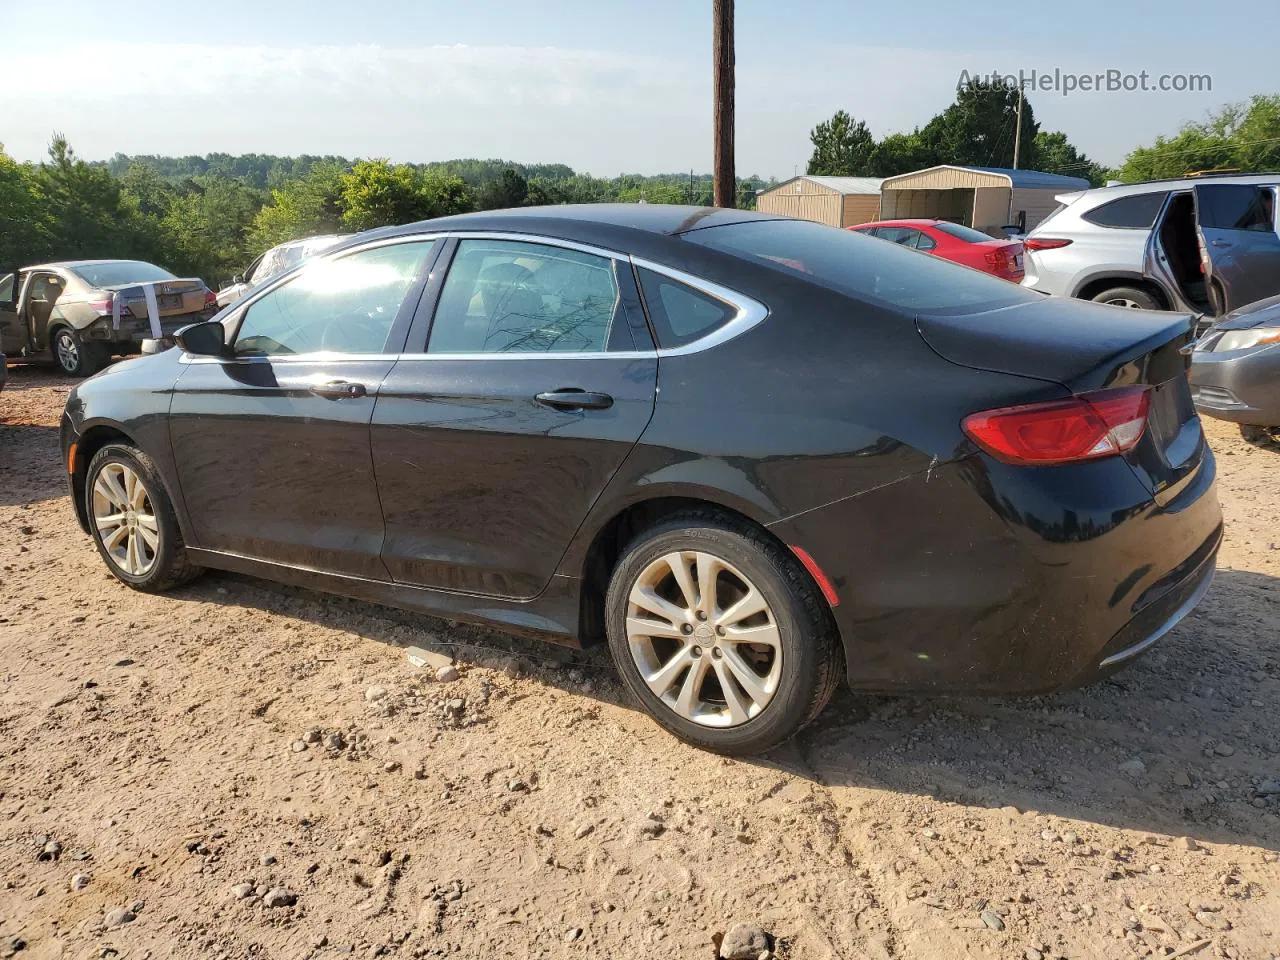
<box><xmin>0</xmin><ymin>0</ymin><xmax>1280</xmax><ymax>178</ymax></box>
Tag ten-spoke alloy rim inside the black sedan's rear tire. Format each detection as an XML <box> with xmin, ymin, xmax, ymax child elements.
<box><xmin>627</xmin><ymin>550</ymin><xmax>782</xmax><ymax>727</ymax></box>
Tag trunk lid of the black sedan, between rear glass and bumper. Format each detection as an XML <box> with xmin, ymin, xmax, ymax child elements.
<box><xmin>916</xmin><ymin>297</ymin><xmax>1204</xmax><ymax>503</ymax></box>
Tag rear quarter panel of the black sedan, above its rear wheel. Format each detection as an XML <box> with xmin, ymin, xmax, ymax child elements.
<box><xmin>559</xmin><ymin>278</ymin><xmax>1064</xmax><ymax>576</ymax></box>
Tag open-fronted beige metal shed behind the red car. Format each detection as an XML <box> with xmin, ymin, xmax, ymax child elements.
<box><xmin>879</xmin><ymin>164</ymin><xmax>1089</xmax><ymax>237</ymax></box>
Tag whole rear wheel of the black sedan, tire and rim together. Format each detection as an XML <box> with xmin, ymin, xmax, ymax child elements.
<box><xmin>605</xmin><ymin>511</ymin><xmax>842</xmax><ymax>755</ymax></box>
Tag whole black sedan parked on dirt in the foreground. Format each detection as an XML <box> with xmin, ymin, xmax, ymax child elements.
<box><xmin>61</xmin><ymin>205</ymin><xmax>1221</xmax><ymax>753</ymax></box>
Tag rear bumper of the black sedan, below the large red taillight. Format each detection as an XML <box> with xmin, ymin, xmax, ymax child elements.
<box><xmin>776</xmin><ymin>447</ymin><xmax>1222</xmax><ymax>694</ymax></box>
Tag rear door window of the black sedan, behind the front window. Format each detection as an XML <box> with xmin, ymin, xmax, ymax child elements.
<box><xmin>426</xmin><ymin>239</ymin><xmax>630</xmax><ymax>353</ymax></box>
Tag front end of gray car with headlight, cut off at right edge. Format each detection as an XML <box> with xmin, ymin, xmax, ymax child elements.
<box><xmin>1192</xmin><ymin>297</ymin><xmax>1280</xmax><ymax>442</ymax></box>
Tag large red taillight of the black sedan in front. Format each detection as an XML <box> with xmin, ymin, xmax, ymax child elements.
<box><xmin>961</xmin><ymin>387</ymin><xmax>1151</xmax><ymax>466</ymax></box>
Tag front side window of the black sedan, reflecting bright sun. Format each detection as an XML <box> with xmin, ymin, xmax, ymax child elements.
<box><xmin>236</xmin><ymin>241</ymin><xmax>434</xmax><ymax>357</ymax></box>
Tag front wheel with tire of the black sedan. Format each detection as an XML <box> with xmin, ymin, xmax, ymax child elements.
<box><xmin>84</xmin><ymin>443</ymin><xmax>201</xmax><ymax>593</ymax></box>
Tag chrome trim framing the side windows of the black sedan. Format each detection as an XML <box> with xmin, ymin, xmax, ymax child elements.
<box><xmin>179</xmin><ymin>230</ymin><xmax>769</xmax><ymax>364</ymax></box>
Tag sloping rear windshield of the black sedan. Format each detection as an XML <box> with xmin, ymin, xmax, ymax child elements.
<box><xmin>685</xmin><ymin>220</ymin><xmax>1043</xmax><ymax>314</ymax></box>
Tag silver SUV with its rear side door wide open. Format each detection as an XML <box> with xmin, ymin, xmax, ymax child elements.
<box><xmin>1023</xmin><ymin>173</ymin><xmax>1280</xmax><ymax>317</ymax></box>
